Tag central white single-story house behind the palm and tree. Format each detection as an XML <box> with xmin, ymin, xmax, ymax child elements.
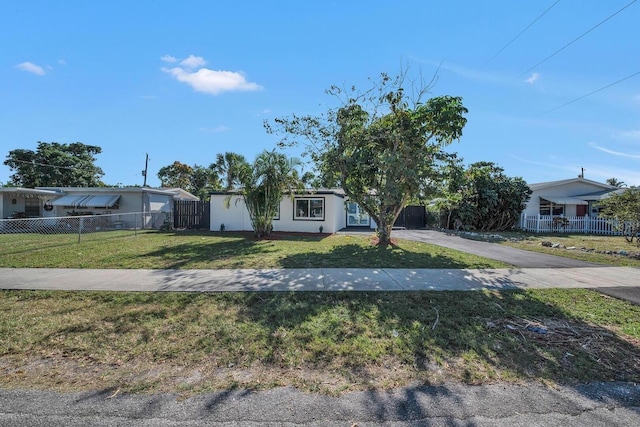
<box><xmin>210</xmin><ymin>189</ymin><xmax>376</xmax><ymax>233</ymax></box>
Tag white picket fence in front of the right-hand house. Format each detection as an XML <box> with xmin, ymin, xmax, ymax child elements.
<box><xmin>520</xmin><ymin>213</ymin><xmax>622</xmax><ymax>235</ymax></box>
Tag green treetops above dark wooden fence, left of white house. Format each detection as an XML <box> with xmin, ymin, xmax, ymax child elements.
<box><xmin>158</xmin><ymin>160</ymin><xmax>220</xmax><ymax>200</ymax></box>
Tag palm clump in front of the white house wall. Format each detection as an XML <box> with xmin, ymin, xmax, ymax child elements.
<box><xmin>234</xmin><ymin>151</ymin><xmax>301</xmax><ymax>238</ymax></box>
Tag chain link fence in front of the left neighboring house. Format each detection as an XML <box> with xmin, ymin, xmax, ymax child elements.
<box><xmin>0</xmin><ymin>212</ymin><xmax>172</xmax><ymax>242</ymax></box>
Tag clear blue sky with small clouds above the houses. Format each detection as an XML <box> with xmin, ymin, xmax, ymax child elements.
<box><xmin>0</xmin><ymin>0</ymin><xmax>640</xmax><ymax>186</ymax></box>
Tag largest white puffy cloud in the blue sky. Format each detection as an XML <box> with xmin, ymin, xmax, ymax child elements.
<box><xmin>162</xmin><ymin>67</ymin><xmax>262</xmax><ymax>95</ymax></box>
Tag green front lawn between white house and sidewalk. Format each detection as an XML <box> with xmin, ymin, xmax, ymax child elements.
<box><xmin>0</xmin><ymin>231</ymin><xmax>508</xmax><ymax>269</ymax></box>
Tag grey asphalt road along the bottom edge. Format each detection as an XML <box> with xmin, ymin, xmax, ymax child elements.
<box><xmin>0</xmin><ymin>383</ymin><xmax>640</xmax><ymax>427</ymax></box>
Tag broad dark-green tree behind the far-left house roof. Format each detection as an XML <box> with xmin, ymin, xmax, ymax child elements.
<box><xmin>4</xmin><ymin>142</ymin><xmax>104</xmax><ymax>188</ymax></box>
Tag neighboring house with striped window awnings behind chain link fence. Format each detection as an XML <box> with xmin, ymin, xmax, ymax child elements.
<box><xmin>0</xmin><ymin>187</ymin><xmax>198</xmax><ymax>227</ymax></box>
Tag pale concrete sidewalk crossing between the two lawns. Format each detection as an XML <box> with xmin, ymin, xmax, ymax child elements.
<box><xmin>0</xmin><ymin>266</ymin><xmax>640</xmax><ymax>292</ymax></box>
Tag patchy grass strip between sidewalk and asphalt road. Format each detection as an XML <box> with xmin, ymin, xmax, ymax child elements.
<box><xmin>0</xmin><ymin>290</ymin><xmax>640</xmax><ymax>395</ymax></box>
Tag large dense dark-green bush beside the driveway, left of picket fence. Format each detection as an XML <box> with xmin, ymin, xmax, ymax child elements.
<box><xmin>440</xmin><ymin>162</ymin><xmax>531</xmax><ymax>231</ymax></box>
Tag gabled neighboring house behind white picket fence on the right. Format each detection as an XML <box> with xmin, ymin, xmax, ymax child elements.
<box><xmin>520</xmin><ymin>177</ymin><xmax>624</xmax><ymax>233</ymax></box>
